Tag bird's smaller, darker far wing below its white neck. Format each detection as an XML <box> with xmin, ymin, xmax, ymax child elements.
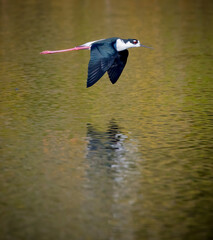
<box><xmin>107</xmin><ymin>50</ymin><xmax>129</xmax><ymax>84</ymax></box>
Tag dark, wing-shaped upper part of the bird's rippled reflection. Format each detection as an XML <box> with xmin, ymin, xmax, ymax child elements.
<box><xmin>87</xmin><ymin>120</ymin><xmax>127</xmax><ymax>167</ymax></box>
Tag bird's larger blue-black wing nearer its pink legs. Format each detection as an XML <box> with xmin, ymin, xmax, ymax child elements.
<box><xmin>87</xmin><ymin>42</ymin><xmax>117</xmax><ymax>87</ymax></box>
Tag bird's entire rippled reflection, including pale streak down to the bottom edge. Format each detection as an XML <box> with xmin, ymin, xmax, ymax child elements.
<box><xmin>82</xmin><ymin>120</ymin><xmax>141</xmax><ymax>239</ymax></box>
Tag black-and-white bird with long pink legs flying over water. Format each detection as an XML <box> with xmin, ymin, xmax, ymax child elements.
<box><xmin>40</xmin><ymin>37</ymin><xmax>152</xmax><ymax>88</ymax></box>
